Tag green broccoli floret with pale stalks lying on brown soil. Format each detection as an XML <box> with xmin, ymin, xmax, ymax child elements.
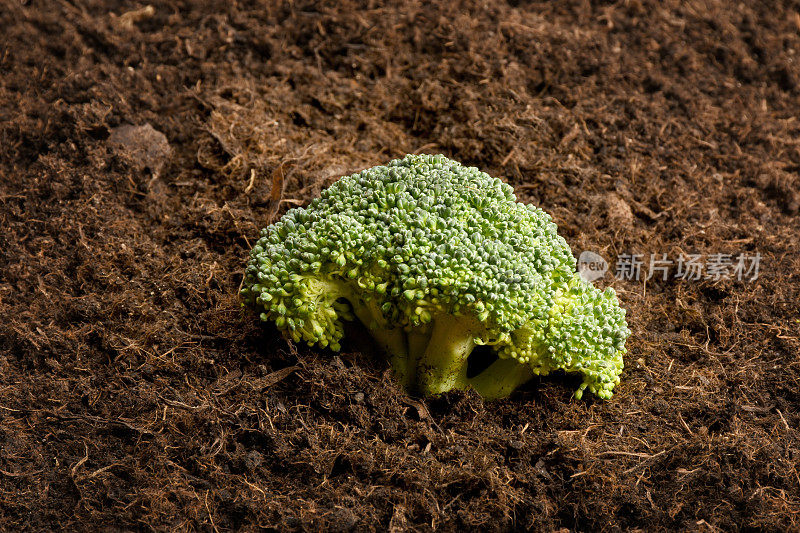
<box><xmin>241</xmin><ymin>155</ymin><xmax>630</xmax><ymax>399</ymax></box>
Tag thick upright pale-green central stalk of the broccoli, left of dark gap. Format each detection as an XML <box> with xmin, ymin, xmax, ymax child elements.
<box><xmin>416</xmin><ymin>315</ymin><xmax>475</xmax><ymax>396</ymax></box>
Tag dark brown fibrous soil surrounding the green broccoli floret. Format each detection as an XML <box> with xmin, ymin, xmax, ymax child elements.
<box><xmin>0</xmin><ymin>0</ymin><xmax>800</xmax><ymax>531</ymax></box>
